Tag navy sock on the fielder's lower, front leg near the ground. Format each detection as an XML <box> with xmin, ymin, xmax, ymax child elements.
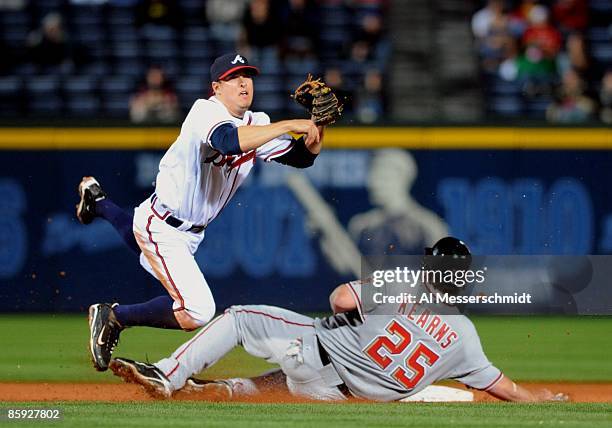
<box><xmin>113</xmin><ymin>295</ymin><xmax>182</xmax><ymax>330</ymax></box>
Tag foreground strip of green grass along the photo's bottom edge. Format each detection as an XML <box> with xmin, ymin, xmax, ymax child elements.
<box><xmin>0</xmin><ymin>402</ymin><xmax>612</xmax><ymax>428</ymax></box>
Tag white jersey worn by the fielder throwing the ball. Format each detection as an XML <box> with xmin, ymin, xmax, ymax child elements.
<box><xmin>155</xmin><ymin>96</ymin><xmax>293</xmax><ymax>226</ymax></box>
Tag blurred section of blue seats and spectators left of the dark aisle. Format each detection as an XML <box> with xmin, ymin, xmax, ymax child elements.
<box><xmin>0</xmin><ymin>0</ymin><xmax>390</xmax><ymax>123</ymax></box>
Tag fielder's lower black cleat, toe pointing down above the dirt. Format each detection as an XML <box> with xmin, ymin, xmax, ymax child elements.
<box><xmin>89</xmin><ymin>303</ymin><xmax>123</xmax><ymax>372</ymax></box>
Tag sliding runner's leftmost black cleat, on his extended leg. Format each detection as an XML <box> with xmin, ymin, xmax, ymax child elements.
<box><xmin>110</xmin><ymin>358</ymin><xmax>173</xmax><ymax>399</ymax></box>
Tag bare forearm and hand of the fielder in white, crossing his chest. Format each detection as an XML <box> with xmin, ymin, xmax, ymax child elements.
<box><xmin>238</xmin><ymin>119</ymin><xmax>320</xmax><ymax>153</ymax></box>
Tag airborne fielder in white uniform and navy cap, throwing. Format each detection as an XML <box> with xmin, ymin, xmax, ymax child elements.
<box><xmin>77</xmin><ymin>53</ymin><xmax>340</xmax><ymax>371</ymax></box>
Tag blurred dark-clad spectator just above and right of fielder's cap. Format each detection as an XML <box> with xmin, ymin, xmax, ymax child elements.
<box><xmin>239</xmin><ymin>0</ymin><xmax>282</xmax><ymax>58</ymax></box>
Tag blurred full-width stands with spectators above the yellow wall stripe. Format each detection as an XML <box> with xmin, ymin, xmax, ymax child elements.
<box><xmin>0</xmin><ymin>0</ymin><xmax>612</xmax><ymax>124</ymax></box>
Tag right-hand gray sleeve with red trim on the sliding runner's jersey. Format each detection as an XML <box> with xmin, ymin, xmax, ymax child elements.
<box><xmin>452</xmin><ymin>334</ymin><xmax>504</xmax><ymax>391</ymax></box>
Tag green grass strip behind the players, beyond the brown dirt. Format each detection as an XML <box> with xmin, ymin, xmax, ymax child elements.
<box><xmin>0</xmin><ymin>315</ymin><xmax>612</xmax><ymax>382</ymax></box>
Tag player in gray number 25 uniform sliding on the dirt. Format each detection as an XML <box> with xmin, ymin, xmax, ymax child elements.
<box><xmin>110</xmin><ymin>237</ymin><xmax>560</xmax><ymax>401</ymax></box>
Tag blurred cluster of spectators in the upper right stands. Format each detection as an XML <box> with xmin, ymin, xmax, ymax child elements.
<box><xmin>472</xmin><ymin>0</ymin><xmax>612</xmax><ymax>124</ymax></box>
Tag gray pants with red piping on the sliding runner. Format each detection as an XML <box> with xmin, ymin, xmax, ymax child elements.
<box><xmin>155</xmin><ymin>305</ymin><xmax>345</xmax><ymax>400</ymax></box>
